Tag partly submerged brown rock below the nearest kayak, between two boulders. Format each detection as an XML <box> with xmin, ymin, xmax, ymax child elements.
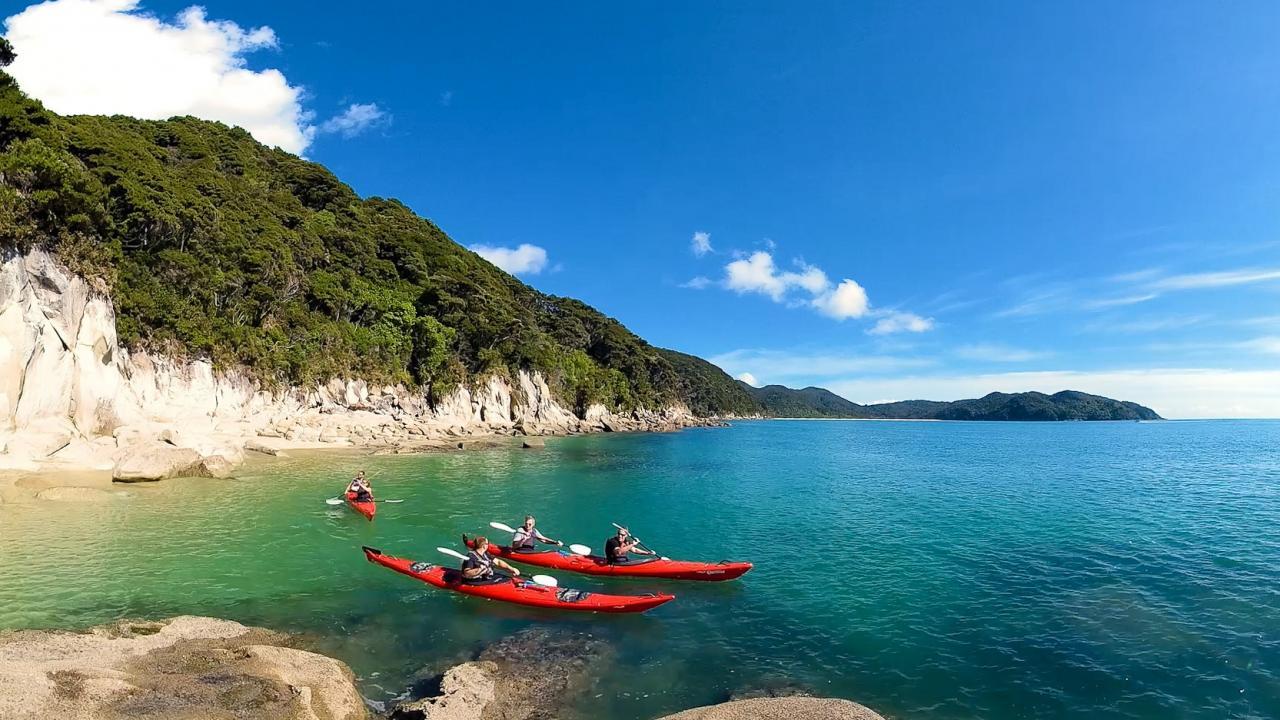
<box><xmin>392</xmin><ymin>628</ymin><xmax>613</xmax><ymax>720</ymax></box>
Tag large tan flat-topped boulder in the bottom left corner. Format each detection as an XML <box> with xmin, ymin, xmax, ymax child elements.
<box><xmin>0</xmin><ymin>616</ymin><xmax>367</xmax><ymax>720</ymax></box>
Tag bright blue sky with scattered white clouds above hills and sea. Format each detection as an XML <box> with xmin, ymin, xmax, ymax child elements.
<box><xmin>3</xmin><ymin>0</ymin><xmax>1280</xmax><ymax>418</ymax></box>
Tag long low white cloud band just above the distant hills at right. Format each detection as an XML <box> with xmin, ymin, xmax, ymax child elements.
<box><xmin>827</xmin><ymin>368</ymin><xmax>1280</xmax><ymax>418</ymax></box>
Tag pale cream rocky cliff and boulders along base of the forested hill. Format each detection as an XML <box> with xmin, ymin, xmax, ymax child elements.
<box><xmin>0</xmin><ymin>249</ymin><xmax>707</xmax><ymax>480</ymax></box>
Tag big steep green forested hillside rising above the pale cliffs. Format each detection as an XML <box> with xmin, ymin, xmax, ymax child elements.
<box><xmin>0</xmin><ymin>50</ymin><xmax>751</xmax><ymax>414</ymax></box>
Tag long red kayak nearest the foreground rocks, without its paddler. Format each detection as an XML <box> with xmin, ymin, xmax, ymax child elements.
<box><xmin>364</xmin><ymin>546</ymin><xmax>676</xmax><ymax>612</ymax></box>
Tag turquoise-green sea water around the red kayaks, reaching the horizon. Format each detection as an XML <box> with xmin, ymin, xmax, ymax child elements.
<box><xmin>0</xmin><ymin>421</ymin><xmax>1280</xmax><ymax>720</ymax></box>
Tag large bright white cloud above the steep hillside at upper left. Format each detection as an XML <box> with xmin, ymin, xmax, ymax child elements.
<box><xmin>5</xmin><ymin>0</ymin><xmax>378</xmax><ymax>154</ymax></box>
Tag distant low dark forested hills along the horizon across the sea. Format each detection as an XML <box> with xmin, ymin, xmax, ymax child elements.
<box><xmin>740</xmin><ymin>383</ymin><xmax>1160</xmax><ymax>420</ymax></box>
